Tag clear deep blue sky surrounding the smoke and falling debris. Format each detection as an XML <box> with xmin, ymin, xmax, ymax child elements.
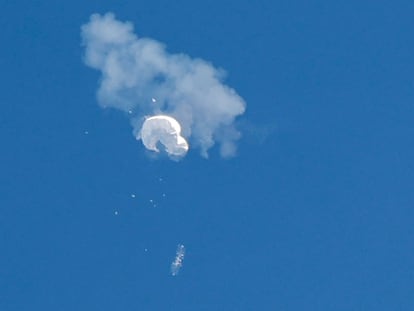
<box><xmin>0</xmin><ymin>0</ymin><xmax>414</xmax><ymax>311</ymax></box>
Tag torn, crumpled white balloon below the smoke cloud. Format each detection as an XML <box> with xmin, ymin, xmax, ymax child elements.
<box><xmin>141</xmin><ymin>115</ymin><xmax>188</xmax><ymax>157</ymax></box>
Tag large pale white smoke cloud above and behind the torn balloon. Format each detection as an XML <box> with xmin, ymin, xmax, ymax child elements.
<box><xmin>81</xmin><ymin>13</ymin><xmax>245</xmax><ymax>157</ymax></box>
